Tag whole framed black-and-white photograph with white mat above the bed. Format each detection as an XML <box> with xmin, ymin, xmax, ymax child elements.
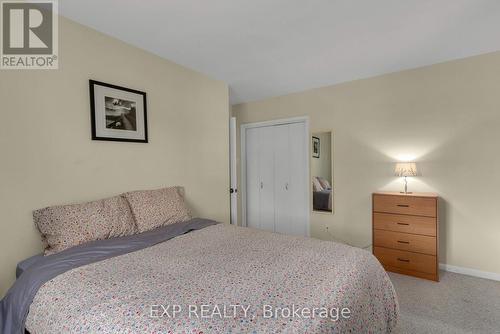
<box><xmin>89</xmin><ymin>80</ymin><xmax>148</xmax><ymax>143</ymax></box>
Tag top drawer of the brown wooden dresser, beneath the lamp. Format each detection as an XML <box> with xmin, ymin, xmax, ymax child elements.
<box><xmin>373</xmin><ymin>194</ymin><xmax>437</xmax><ymax>217</ymax></box>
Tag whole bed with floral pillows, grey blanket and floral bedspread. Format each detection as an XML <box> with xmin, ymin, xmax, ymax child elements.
<box><xmin>0</xmin><ymin>187</ymin><xmax>399</xmax><ymax>334</ymax></box>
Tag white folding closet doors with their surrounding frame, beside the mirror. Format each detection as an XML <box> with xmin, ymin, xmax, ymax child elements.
<box><xmin>241</xmin><ymin>119</ymin><xmax>309</xmax><ymax>236</ymax></box>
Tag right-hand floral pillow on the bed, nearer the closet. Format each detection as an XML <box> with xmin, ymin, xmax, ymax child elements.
<box><xmin>122</xmin><ymin>187</ymin><xmax>191</xmax><ymax>232</ymax></box>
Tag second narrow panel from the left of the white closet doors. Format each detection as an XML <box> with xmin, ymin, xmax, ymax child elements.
<box><xmin>259</xmin><ymin>126</ymin><xmax>274</xmax><ymax>231</ymax></box>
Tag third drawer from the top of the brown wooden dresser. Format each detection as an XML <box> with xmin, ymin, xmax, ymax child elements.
<box><xmin>373</xmin><ymin>230</ymin><xmax>436</xmax><ymax>255</ymax></box>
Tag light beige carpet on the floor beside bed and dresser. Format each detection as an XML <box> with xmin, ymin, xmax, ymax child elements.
<box><xmin>389</xmin><ymin>272</ymin><xmax>500</xmax><ymax>334</ymax></box>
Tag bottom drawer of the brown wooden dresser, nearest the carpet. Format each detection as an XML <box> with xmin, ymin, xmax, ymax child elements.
<box><xmin>373</xmin><ymin>247</ymin><xmax>437</xmax><ymax>275</ymax></box>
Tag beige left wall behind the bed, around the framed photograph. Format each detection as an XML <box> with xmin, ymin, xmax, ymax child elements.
<box><xmin>0</xmin><ymin>18</ymin><xmax>229</xmax><ymax>295</ymax></box>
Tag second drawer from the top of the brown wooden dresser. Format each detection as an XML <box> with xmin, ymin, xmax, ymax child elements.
<box><xmin>373</xmin><ymin>212</ymin><xmax>437</xmax><ymax>237</ymax></box>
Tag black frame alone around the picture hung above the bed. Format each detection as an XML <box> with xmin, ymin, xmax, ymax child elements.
<box><xmin>89</xmin><ymin>79</ymin><xmax>148</xmax><ymax>143</ymax></box>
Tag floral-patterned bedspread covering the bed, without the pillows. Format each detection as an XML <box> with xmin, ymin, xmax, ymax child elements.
<box><xmin>26</xmin><ymin>224</ymin><xmax>399</xmax><ymax>334</ymax></box>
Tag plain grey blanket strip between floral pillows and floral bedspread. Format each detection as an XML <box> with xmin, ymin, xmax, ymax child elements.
<box><xmin>0</xmin><ymin>218</ymin><xmax>217</xmax><ymax>334</ymax></box>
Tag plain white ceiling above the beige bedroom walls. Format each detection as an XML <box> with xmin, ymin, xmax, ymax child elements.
<box><xmin>59</xmin><ymin>0</ymin><xmax>500</xmax><ymax>104</ymax></box>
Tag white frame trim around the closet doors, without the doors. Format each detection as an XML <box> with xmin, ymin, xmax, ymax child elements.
<box><xmin>240</xmin><ymin>116</ymin><xmax>311</xmax><ymax>237</ymax></box>
